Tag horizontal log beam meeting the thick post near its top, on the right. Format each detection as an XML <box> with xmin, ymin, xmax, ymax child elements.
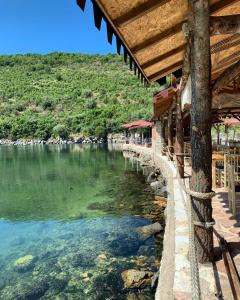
<box><xmin>210</xmin><ymin>15</ymin><xmax>240</xmax><ymax>35</ymax></box>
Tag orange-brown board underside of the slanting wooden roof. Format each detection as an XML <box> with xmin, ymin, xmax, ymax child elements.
<box><xmin>77</xmin><ymin>0</ymin><xmax>240</xmax><ymax>83</ymax></box>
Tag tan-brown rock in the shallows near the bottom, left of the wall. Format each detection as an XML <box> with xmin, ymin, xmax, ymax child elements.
<box><xmin>121</xmin><ymin>269</ymin><xmax>154</xmax><ymax>288</ymax></box>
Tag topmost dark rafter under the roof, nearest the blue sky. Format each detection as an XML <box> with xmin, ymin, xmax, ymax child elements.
<box><xmin>113</xmin><ymin>0</ymin><xmax>170</xmax><ymax>26</ymax></box>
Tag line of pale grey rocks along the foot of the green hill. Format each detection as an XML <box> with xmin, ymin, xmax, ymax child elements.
<box><xmin>0</xmin><ymin>136</ymin><xmax>106</xmax><ymax>146</ymax></box>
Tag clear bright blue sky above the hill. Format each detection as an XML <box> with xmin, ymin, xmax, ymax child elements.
<box><xmin>0</xmin><ymin>0</ymin><xmax>116</xmax><ymax>54</ymax></box>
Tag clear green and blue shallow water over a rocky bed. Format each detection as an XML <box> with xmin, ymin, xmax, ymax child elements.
<box><xmin>0</xmin><ymin>145</ymin><xmax>159</xmax><ymax>300</ymax></box>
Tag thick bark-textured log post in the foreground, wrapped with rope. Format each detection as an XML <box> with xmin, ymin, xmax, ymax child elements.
<box><xmin>189</xmin><ymin>0</ymin><xmax>213</xmax><ymax>263</ymax></box>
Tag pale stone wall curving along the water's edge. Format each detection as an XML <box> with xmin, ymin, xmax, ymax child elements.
<box><xmin>123</xmin><ymin>144</ymin><xmax>216</xmax><ymax>300</ymax></box>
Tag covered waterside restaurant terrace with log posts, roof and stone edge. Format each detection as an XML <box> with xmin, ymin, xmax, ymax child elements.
<box><xmin>77</xmin><ymin>0</ymin><xmax>240</xmax><ymax>300</ymax></box>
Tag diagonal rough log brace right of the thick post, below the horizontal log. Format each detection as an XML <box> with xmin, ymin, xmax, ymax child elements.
<box><xmin>212</xmin><ymin>60</ymin><xmax>240</xmax><ymax>95</ymax></box>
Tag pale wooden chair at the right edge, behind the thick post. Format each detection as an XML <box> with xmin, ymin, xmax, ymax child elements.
<box><xmin>227</xmin><ymin>164</ymin><xmax>240</xmax><ymax>216</ymax></box>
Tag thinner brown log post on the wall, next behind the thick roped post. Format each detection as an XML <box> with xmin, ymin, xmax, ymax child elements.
<box><xmin>175</xmin><ymin>95</ymin><xmax>184</xmax><ymax>178</ymax></box>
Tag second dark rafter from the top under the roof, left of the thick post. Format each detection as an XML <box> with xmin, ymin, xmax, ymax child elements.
<box><xmin>132</xmin><ymin>22</ymin><xmax>183</xmax><ymax>53</ymax></box>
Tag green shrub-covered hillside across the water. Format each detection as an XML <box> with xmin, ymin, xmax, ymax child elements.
<box><xmin>0</xmin><ymin>53</ymin><xmax>156</xmax><ymax>139</ymax></box>
